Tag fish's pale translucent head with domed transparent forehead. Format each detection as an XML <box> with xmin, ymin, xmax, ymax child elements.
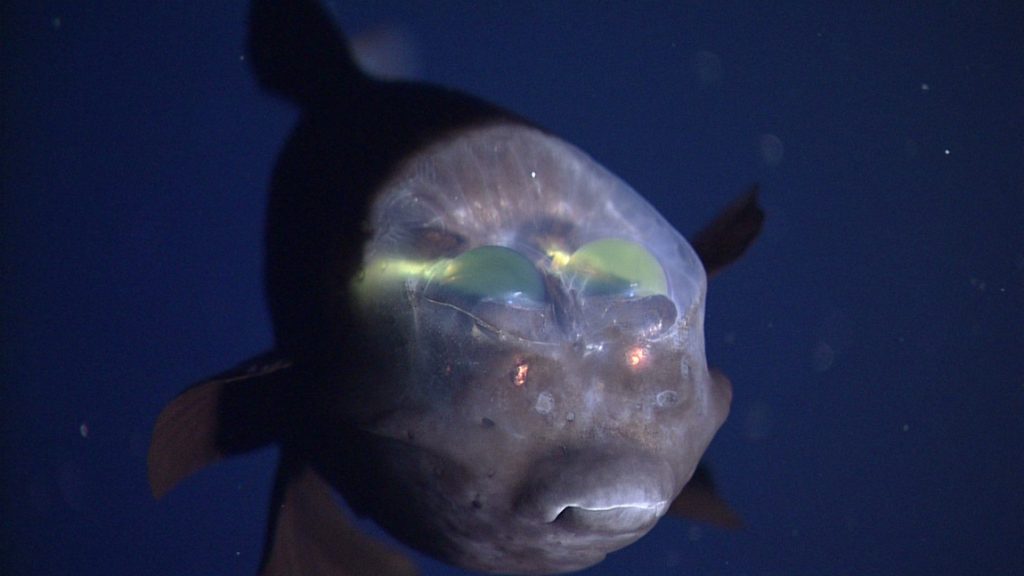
<box><xmin>339</xmin><ymin>123</ymin><xmax>731</xmax><ymax>574</ymax></box>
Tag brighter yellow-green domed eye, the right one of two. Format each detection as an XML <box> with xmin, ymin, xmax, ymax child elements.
<box><xmin>563</xmin><ymin>238</ymin><xmax>669</xmax><ymax>297</ymax></box>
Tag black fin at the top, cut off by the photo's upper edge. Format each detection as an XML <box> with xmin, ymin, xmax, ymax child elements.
<box><xmin>247</xmin><ymin>0</ymin><xmax>367</xmax><ymax>106</ymax></box>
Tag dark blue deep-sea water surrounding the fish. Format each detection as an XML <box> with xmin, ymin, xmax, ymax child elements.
<box><xmin>6</xmin><ymin>1</ymin><xmax>1024</xmax><ymax>576</ymax></box>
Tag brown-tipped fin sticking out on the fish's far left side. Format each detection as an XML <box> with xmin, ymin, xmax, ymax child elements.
<box><xmin>147</xmin><ymin>352</ymin><xmax>291</xmax><ymax>498</ymax></box>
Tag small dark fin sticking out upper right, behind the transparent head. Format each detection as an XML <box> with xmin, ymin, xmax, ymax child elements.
<box><xmin>692</xmin><ymin>184</ymin><xmax>765</xmax><ymax>279</ymax></box>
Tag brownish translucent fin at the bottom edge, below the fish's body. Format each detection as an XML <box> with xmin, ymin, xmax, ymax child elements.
<box><xmin>259</xmin><ymin>448</ymin><xmax>417</xmax><ymax>576</ymax></box>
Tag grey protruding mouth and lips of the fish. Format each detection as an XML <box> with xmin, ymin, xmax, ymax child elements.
<box><xmin>516</xmin><ymin>451</ymin><xmax>676</xmax><ymax>534</ymax></box>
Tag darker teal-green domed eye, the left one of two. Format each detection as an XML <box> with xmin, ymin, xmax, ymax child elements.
<box><xmin>426</xmin><ymin>246</ymin><xmax>545</xmax><ymax>302</ymax></box>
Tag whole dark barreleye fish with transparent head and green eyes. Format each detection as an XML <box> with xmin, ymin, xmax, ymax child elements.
<box><xmin>148</xmin><ymin>0</ymin><xmax>763</xmax><ymax>576</ymax></box>
